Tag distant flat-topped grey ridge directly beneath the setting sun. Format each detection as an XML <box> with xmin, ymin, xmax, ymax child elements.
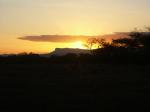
<box><xmin>50</xmin><ymin>48</ymin><xmax>90</xmax><ymax>56</ymax></box>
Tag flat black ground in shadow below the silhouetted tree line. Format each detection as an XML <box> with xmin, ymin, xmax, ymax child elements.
<box><xmin>0</xmin><ymin>64</ymin><xmax>150</xmax><ymax>112</ymax></box>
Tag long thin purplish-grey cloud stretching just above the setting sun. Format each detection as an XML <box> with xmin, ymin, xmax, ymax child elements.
<box><xmin>18</xmin><ymin>32</ymin><xmax>129</xmax><ymax>43</ymax></box>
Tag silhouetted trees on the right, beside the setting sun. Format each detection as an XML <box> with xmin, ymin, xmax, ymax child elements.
<box><xmin>85</xmin><ymin>27</ymin><xmax>150</xmax><ymax>50</ymax></box>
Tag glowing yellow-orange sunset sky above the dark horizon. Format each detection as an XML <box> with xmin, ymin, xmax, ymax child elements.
<box><xmin>0</xmin><ymin>0</ymin><xmax>150</xmax><ymax>54</ymax></box>
